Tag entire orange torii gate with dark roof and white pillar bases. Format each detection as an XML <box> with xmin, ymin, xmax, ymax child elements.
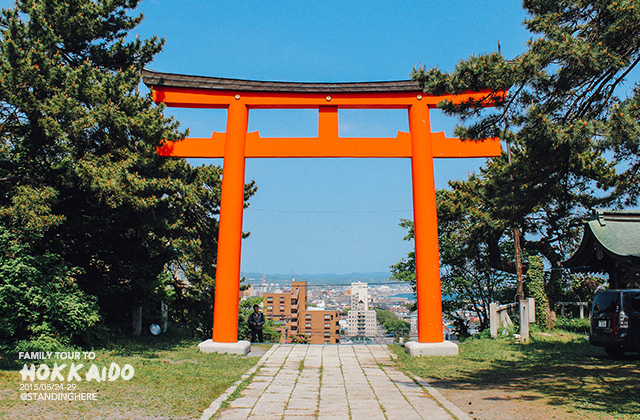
<box><xmin>142</xmin><ymin>70</ymin><xmax>500</xmax><ymax>355</ymax></box>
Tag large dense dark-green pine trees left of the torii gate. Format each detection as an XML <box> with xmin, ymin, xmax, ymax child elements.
<box><xmin>0</xmin><ymin>0</ymin><xmax>255</xmax><ymax>339</ymax></box>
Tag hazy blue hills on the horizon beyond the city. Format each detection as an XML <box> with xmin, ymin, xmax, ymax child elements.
<box><xmin>241</xmin><ymin>272</ymin><xmax>392</xmax><ymax>285</ymax></box>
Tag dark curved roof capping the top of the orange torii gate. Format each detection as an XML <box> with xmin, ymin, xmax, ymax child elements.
<box><xmin>142</xmin><ymin>69</ymin><xmax>422</xmax><ymax>93</ymax></box>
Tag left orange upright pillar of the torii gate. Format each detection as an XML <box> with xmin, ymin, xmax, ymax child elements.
<box><xmin>213</xmin><ymin>102</ymin><xmax>249</xmax><ymax>343</ymax></box>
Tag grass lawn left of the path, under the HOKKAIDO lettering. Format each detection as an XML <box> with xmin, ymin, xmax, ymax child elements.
<box><xmin>0</xmin><ymin>337</ymin><xmax>268</xmax><ymax>419</ymax></box>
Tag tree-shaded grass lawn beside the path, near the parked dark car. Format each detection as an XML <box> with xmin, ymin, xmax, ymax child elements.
<box><xmin>393</xmin><ymin>331</ymin><xmax>640</xmax><ymax>419</ymax></box>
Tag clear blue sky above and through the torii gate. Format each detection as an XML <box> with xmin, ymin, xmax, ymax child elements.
<box><xmin>0</xmin><ymin>0</ymin><xmax>530</xmax><ymax>274</ymax></box>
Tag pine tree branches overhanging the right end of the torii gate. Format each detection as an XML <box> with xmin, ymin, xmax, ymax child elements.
<box><xmin>413</xmin><ymin>0</ymin><xmax>640</xmax><ymax>312</ymax></box>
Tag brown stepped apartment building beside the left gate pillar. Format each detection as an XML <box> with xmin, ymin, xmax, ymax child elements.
<box><xmin>263</xmin><ymin>281</ymin><xmax>340</xmax><ymax>344</ymax></box>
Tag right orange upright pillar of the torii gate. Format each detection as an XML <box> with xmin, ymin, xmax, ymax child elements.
<box><xmin>409</xmin><ymin>102</ymin><xmax>443</xmax><ymax>343</ymax></box>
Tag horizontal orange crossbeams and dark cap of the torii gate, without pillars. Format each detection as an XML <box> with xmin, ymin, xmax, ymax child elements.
<box><xmin>142</xmin><ymin>70</ymin><xmax>500</xmax><ymax>158</ymax></box>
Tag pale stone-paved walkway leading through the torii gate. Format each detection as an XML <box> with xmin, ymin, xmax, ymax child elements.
<box><xmin>201</xmin><ymin>344</ymin><xmax>471</xmax><ymax>420</ymax></box>
